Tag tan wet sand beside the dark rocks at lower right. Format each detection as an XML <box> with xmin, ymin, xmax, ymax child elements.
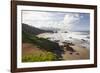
<box><xmin>62</xmin><ymin>45</ymin><xmax>89</xmax><ymax>60</ymax></box>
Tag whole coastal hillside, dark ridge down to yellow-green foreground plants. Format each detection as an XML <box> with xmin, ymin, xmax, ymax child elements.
<box><xmin>22</xmin><ymin>24</ymin><xmax>63</xmax><ymax>62</ymax></box>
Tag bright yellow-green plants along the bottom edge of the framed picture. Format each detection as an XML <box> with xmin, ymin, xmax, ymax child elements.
<box><xmin>22</xmin><ymin>51</ymin><xmax>57</xmax><ymax>62</ymax></box>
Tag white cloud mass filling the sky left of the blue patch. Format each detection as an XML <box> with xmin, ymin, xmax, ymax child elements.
<box><xmin>22</xmin><ymin>11</ymin><xmax>80</xmax><ymax>30</ymax></box>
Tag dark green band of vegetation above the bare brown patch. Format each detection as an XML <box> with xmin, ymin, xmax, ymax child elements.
<box><xmin>22</xmin><ymin>32</ymin><xmax>60</xmax><ymax>51</ymax></box>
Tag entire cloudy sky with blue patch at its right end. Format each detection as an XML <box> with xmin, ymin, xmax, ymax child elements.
<box><xmin>22</xmin><ymin>10</ymin><xmax>90</xmax><ymax>31</ymax></box>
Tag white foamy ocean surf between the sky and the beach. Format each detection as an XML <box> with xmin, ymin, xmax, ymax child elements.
<box><xmin>37</xmin><ymin>31</ymin><xmax>90</xmax><ymax>49</ymax></box>
